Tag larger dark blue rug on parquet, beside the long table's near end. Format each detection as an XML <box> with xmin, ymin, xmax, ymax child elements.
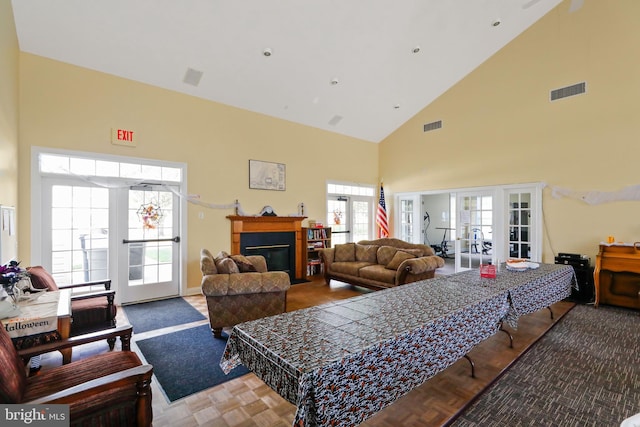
<box><xmin>136</xmin><ymin>325</ymin><xmax>249</xmax><ymax>402</ymax></box>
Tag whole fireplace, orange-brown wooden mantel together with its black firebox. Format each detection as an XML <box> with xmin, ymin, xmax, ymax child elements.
<box><xmin>227</xmin><ymin>215</ymin><xmax>306</xmax><ymax>282</ymax></box>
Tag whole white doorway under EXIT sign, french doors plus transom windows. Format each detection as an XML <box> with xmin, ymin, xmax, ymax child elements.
<box><xmin>31</xmin><ymin>150</ymin><xmax>186</xmax><ymax>304</ymax></box>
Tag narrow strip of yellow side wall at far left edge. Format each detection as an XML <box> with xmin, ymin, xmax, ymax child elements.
<box><xmin>0</xmin><ymin>0</ymin><xmax>19</xmax><ymax>209</ymax></box>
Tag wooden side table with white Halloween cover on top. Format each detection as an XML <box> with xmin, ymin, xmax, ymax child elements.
<box><xmin>2</xmin><ymin>289</ymin><xmax>71</xmax><ymax>363</ymax></box>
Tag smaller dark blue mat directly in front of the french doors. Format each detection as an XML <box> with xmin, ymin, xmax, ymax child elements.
<box><xmin>123</xmin><ymin>298</ymin><xmax>206</xmax><ymax>334</ymax></box>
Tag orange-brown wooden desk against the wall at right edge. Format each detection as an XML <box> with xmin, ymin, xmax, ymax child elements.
<box><xmin>593</xmin><ymin>242</ymin><xmax>640</xmax><ymax>309</ymax></box>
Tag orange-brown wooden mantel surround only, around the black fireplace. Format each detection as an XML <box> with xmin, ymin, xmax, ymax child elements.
<box><xmin>227</xmin><ymin>215</ymin><xmax>306</xmax><ymax>279</ymax></box>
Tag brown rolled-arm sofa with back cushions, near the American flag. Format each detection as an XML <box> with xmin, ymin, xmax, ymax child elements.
<box><xmin>320</xmin><ymin>238</ymin><xmax>444</xmax><ymax>289</ymax></box>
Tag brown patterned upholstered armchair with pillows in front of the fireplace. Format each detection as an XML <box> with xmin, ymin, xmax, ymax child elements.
<box><xmin>200</xmin><ymin>249</ymin><xmax>291</xmax><ymax>338</ymax></box>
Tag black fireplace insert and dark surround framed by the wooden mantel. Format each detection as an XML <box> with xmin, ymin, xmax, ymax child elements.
<box><xmin>240</xmin><ymin>232</ymin><xmax>296</xmax><ymax>281</ymax></box>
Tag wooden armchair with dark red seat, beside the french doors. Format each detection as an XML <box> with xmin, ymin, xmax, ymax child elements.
<box><xmin>27</xmin><ymin>266</ymin><xmax>117</xmax><ymax>350</ymax></box>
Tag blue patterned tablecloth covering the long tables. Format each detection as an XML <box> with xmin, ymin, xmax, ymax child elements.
<box><xmin>220</xmin><ymin>264</ymin><xmax>574</xmax><ymax>426</ymax></box>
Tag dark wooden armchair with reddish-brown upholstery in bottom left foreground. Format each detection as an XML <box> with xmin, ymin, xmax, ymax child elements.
<box><xmin>0</xmin><ymin>325</ymin><xmax>153</xmax><ymax>426</ymax></box>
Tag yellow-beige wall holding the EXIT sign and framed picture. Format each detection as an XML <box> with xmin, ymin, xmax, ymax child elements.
<box><xmin>19</xmin><ymin>53</ymin><xmax>378</xmax><ymax>289</ymax></box>
